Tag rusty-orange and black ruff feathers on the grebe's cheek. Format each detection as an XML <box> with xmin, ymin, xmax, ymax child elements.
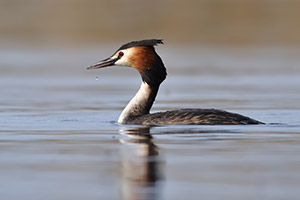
<box><xmin>129</xmin><ymin>46</ymin><xmax>167</xmax><ymax>86</ymax></box>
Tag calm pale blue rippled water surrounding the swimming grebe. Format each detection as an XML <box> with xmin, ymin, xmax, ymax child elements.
<box><xmin>0</xmin><ymin>46</ymin><xmax>300</xmax><ymax>200</ymax></box>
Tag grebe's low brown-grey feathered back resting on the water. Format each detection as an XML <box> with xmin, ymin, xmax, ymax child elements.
<box><xmin>128</xmin><ymin>109</ymin><xmax>263</xmax><ymax>125</ymax></box>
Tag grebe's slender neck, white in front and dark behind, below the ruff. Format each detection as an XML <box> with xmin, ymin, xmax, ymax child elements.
<box><xmin>118</xmin><ymin>82</ymin><xmax>159</xmax><ymax>124</ymax></box>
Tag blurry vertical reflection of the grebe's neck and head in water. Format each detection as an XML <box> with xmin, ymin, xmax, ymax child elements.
<box><xmin>120</xmin><ymin>127</ymin><xmax>162</xmax><ymax>200</ymax></box>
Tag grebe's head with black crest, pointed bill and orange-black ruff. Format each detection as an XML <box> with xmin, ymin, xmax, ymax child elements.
<box><xmin>87</xmin><ymin>39</ymin><xmax>167</xmax><ymax>85</ymax></box>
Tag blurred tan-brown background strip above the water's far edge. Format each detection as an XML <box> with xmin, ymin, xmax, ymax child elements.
<box><xmin>0</xmin><ymin>0</ymin><xmax>300</xmax><ymax>48</ymax></box>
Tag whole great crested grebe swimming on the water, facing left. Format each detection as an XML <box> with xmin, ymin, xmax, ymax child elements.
<box><xmin>87</xmin><ymin>39</ymin><xmax>263</xmax><ymax>125</ymax></box>
